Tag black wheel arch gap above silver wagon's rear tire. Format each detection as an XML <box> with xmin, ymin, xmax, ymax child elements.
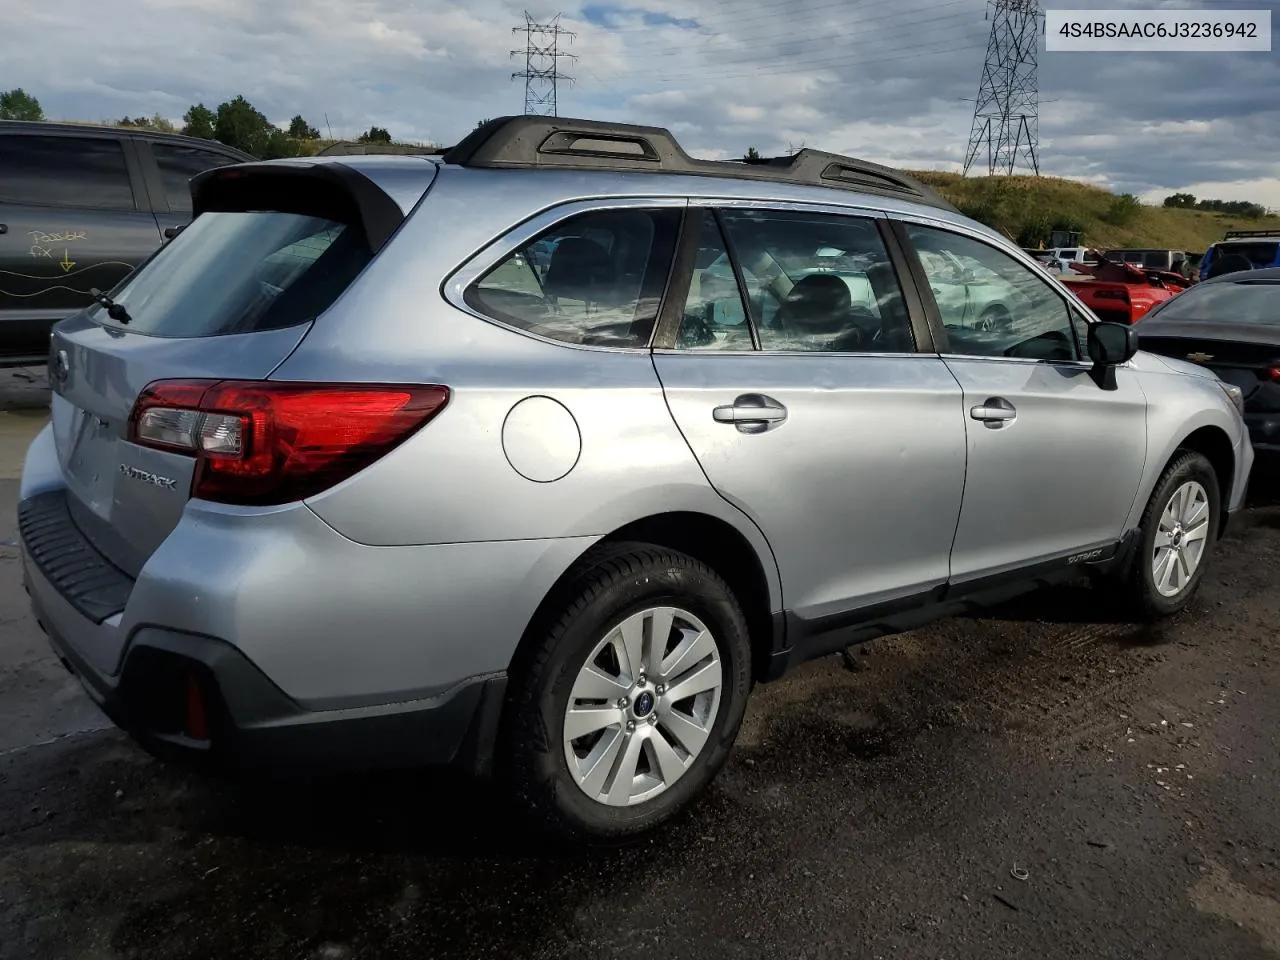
<box><xmin>512</xmin><ymin>512</ymin><xmax>773</xmax><ymax>680</ymax></box>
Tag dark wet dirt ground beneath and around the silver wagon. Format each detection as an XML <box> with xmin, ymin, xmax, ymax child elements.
<box><xmin>0</xmin><ymin>413</ymin><xmax>1280</xmax><ymax>960</ymax></box>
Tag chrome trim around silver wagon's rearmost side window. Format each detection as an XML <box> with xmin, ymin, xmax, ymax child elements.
<box><xmin>440</xmin><ymin>195</ymin><xmax>689</xmax><ymax>355</ymax></box>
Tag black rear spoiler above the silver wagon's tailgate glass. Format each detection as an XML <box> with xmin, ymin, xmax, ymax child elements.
<box><xmin>191</xmin><ymin>161</ymin><xmax>404</xmax><ymax>253</ymax></box>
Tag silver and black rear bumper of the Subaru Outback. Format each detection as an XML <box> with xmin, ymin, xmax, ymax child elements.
<box><xmin>18</xmin><ymin>429</ymin><xmax>595</xmax><ymax>772</ymax></box>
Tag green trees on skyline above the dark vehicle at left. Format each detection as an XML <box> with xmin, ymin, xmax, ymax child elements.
<box><xmin>0</xmin><ymin>87</ymin><xmax>392</xmax><ymax>160</ymax></box>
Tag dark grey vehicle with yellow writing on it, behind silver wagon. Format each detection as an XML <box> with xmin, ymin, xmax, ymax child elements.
<box><xmin>0</xmin><ymin>120</ymin><xmax>252</xmax><ymax>366</ymax></box>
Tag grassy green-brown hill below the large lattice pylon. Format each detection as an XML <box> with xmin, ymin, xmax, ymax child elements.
<box><xmin>911</xmin><ymin>170</ymin><xmax>1280</xmax><ymax>252</ymax></box>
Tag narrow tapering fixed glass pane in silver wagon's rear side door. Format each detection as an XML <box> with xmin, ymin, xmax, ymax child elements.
<box><xmin>676</xmin><ymin>210</ymin><xmax>755</xmax><ymax>349</ymax></box>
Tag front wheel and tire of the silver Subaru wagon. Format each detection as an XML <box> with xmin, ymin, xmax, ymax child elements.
<box><xmin>1119</xmin><ymin>451</ymin><xmax>1222</xmax><ymax>621</ymax></box>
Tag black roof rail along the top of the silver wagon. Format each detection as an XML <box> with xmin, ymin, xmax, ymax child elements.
<box><xmin>443</xmin><ymin>116</ymin><xmax>956</xmax><ymax>212</ymax></box>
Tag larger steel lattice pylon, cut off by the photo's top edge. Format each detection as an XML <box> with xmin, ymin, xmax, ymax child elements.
<box><xmin>964</xmin><ymin>0</ymin><xmax>1041</xmax><ymax>177</ymax></box>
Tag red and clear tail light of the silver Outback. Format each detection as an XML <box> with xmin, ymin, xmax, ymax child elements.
<box><xmin>129</xmin><ymin>380</ymin><xmax>449</xmax><ymax>506</ymax></box>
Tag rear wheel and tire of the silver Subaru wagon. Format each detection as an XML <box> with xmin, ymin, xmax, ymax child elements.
<box><xmin>503</xmin><ymin>544</ymin><xmax>751</xmax><ymax>842</ymax></box>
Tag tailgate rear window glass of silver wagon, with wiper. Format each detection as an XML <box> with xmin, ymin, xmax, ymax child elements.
<box><xmin>101</xmin><ymin>211</ymin><xmax>372</xmax><ymax>337</ymax></box>
